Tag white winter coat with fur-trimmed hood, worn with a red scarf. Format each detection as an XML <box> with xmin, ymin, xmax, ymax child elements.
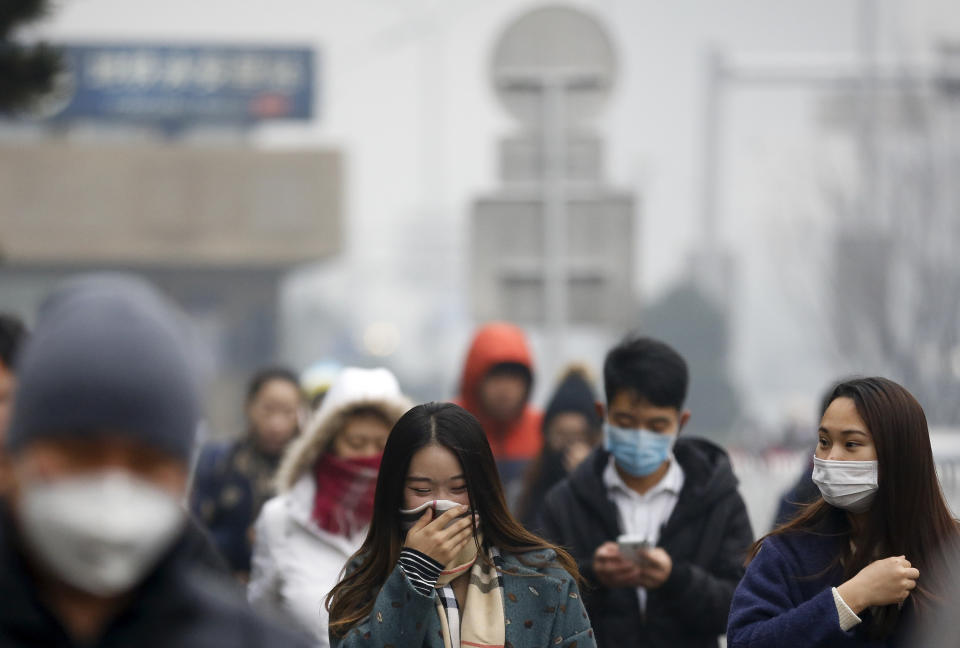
<box><xmin>247</xmin><ymin>368</ymin><xmax>410</xmax><ymax>646</ymax></box>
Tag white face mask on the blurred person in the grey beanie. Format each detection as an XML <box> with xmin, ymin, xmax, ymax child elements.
<box><xmin>18</xmin><ymin>470</ymin><xmax>186</xmax><ymax>596</ymax></box>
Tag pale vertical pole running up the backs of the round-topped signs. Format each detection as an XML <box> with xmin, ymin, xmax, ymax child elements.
<box><xmin>540</xmin><ymin>75</ymin><xmax>567</xmax><ymax>373</ymax></box>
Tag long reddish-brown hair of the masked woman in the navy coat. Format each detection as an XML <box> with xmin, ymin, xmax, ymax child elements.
<box><xmin>747</xmin><ymin>378</ymin><xmax>958</xmax><ymax>637</ymax></box>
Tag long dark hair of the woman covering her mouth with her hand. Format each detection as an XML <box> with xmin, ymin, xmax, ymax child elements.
<box><xmin>326</xmin><ymin>403</ymin><xmax>580</xmax><ymax>636</ymax></box>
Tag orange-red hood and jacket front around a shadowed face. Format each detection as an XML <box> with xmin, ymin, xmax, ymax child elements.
<box><xmin>457</xmin><ymin>322</ymin><xmax>542</xmax><ymax>459</ymax></box>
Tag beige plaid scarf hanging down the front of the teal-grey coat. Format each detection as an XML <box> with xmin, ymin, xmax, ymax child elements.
<box><xmin>437</xmin><ymin>539</ymin><xmax>506</xmax><ymax>648</ymax></box>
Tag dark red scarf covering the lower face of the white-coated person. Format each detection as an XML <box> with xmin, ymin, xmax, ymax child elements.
<box><xmin>313</xmin><ymin>452</ymin><xmax>383</xmax><ymax>537</ymax></box>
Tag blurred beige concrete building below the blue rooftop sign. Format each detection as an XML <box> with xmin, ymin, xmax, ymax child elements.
<box><xmin>0</xmin><ymin>138</ymin><xmax>342</xmax><ymax>434</ymax></box>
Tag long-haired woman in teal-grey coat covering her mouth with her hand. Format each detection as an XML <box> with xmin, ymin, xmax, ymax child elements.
<box><xmin>327</xmin><ymin>403</ymin><xmax>596</xmax><ymax>648</ymax></box>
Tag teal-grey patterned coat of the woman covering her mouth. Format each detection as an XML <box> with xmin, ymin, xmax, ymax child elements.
<box><xmin>330</xmin><ymin>550</ymin><xmax>596</xmax><ymax>648</ymax></box>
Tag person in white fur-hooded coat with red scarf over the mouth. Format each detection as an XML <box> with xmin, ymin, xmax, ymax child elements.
<box><xmin>248</xmin><ymin>367</ymin><xmax>410</xmax><ymax>646</ymax></box>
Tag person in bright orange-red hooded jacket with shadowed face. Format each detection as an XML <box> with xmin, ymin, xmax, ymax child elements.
<box><xmin>456</xmin><ymin>322</ymin><xmax>543</xmax><ymax>489</ymax></box>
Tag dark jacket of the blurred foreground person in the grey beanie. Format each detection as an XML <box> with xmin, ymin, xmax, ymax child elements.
<box><xmin>0</xmin><ymin>515</ymin><xmax>310</xmax><ymax>648</ymax></box>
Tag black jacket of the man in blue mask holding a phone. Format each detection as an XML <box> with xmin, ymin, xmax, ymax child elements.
<box><xmin>542</xmin><ymin>437</ymin><xmax>753</xmax><ymax>648</ymax></box>
